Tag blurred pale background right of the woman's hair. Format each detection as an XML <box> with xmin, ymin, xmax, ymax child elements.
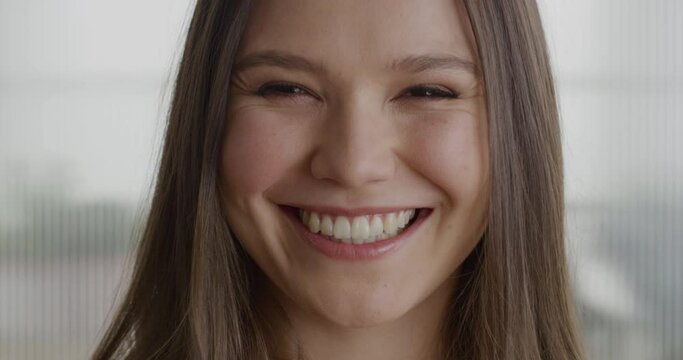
<box><xmin>541</xmin><ymin>0</ymin><xmax>683</xmax><ymax>360</ymax></box>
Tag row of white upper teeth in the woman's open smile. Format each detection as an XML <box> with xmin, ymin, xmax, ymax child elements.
<box><xmin>299</xmin><ymin>209</ymin><xmax>416</xmax><ymax>244</ymax></box>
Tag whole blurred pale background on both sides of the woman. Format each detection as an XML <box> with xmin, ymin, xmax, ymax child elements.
<box><xmin>0</xmin><ymin>0</ymin><xmax>683</xmax><ymax>360</ymax></box>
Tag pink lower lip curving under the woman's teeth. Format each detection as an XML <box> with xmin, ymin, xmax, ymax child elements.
<box><xmin>281</xmin><ymin>206</ymin><xmax>432</xmax><ymax>261</ymax></box>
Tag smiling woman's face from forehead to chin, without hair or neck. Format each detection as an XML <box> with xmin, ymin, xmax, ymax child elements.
<box><xmin>220</xmin><ymin>0</ymin><xmax>489</xmax><ymax>326</ymax></box>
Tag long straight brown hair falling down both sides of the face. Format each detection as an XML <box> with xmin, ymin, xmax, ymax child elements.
<box><xmin>93</xmin><ymin>0</ymin><xmax>584</xmax><ymax>359</ymax></box>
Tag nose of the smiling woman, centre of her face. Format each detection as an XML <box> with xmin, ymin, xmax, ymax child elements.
<box><xmin>311</xmin><ymin>95</ymin><xmax>396</xmax><ymax>188</ymax></box>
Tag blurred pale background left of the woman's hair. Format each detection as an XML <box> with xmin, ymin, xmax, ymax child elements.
<box><xmin>0</xmin><ymin>0</ymin><xmax>192</xmax><ymax>360</ymax></box>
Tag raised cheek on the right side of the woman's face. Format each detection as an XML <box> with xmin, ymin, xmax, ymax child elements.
<box><xmin>406</xmin><ymin>113</ymin><xmax>488</xmax><ymax>200</ymax></box>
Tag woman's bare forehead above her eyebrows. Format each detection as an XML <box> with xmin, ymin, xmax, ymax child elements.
<box><xmin>238</xmin><ymin>0</ymin><xmax>475</xmax><ymax>70</ymax></box>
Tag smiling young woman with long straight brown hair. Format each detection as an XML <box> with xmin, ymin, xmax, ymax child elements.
<box><xmin>94</xmin><ymin>0</ymin><xmax>583</xmax><ymax>359</ymax></box>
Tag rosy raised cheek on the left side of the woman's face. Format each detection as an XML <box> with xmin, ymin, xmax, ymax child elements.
<box><xmin>222</xmin><ymin>111</ymin><xmax>302</xmax><ymax>194</ymax></box>
